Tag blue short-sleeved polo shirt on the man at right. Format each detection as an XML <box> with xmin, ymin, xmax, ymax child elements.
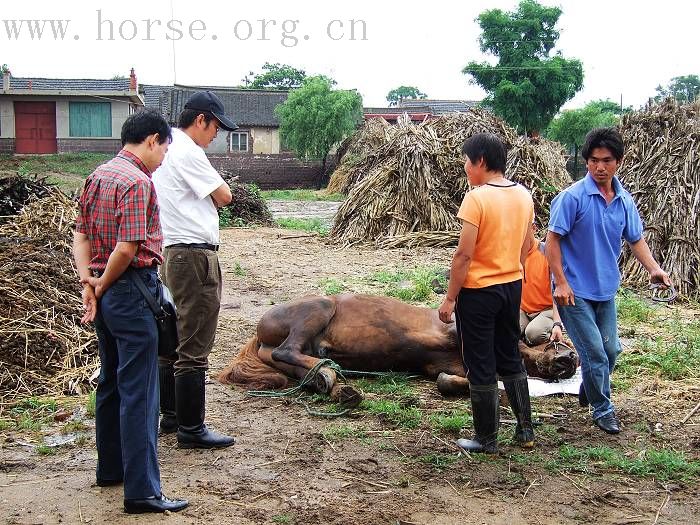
<box><xmin>549</xmin><ymin>173</ymin><xmax>643</xmax><ymax>301</ymax></box>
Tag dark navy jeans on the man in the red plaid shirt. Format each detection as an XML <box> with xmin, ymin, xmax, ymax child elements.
<box><xmin>95</xmin><ymin>269</ymin><xmax>161</xmax><ymax>499</ymax></box>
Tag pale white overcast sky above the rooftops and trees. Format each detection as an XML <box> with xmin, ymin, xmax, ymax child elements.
<box><xmin>0</xmin><ymin>0</ymin><xmax>700</xmax><ymax>108</ymax></box>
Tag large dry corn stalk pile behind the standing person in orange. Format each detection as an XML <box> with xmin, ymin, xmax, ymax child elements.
<box><xmin>329</xmin><ymin>108</ymin><xmax>571</xmax><ymax>248</ymax></box>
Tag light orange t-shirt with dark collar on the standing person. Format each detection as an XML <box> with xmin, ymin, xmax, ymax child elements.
<box><xmin>457</xmin><ymin>179</ymin><xmax>535</xmax><ymax>288</ymax></box>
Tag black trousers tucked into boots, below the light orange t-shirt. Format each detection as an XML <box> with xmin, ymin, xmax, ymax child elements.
<box><xmin>455</xmin><ymin>280</ymin><xmax>525</xmax><ymax>385</ymax></box>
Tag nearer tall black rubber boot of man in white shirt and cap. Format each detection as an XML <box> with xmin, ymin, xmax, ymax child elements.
<box><xmin>175</xmin><ymin>370</ymin><xmax>235</xmax><ymax>448</ymax></box>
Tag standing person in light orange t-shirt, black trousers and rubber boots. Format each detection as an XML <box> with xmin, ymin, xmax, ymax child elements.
<box><xmin>439</xmin><ymin>133</ymin><xmax>535</xmax><ymax>454</ymax></box>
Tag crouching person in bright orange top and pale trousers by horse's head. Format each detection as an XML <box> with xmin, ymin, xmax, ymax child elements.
<box><xmin>520</xmin><ymin>224</ymin><xmax>564</xmax><ymax>346</ymax></box>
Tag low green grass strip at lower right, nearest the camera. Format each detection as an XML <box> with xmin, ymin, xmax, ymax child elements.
<box><xmin>546</xmin><ymin>445</ymin><xmax>700</xmax><ymax>481</ymax></box>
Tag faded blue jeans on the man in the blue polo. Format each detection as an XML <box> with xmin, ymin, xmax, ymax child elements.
<box><xmin>559</xmin><ymin>297</ymin><xmax>622</xmax><ymax>419</ymax></box>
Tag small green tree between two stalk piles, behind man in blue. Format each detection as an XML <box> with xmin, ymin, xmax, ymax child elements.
<box><xmin>545</xmin><ymin>100</ymin><xmax>620</xmax><ymax>175</ymax></box>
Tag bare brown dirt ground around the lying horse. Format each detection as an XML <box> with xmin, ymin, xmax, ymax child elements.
<box><xmin>0</xmin><ymin>228</ymin><xmax>700</xmax><ymax>525</ymax></box>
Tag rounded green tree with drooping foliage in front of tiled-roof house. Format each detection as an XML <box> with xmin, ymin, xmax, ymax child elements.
<box><xmin>275</xmin><ymin>76</ymin><xmax>362</xmax><ymax>186</ymax></box>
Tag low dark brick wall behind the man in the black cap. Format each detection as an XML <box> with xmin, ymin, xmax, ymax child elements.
<box><xmin>208</xmin><ymin>153</ymin><xmax>332</xmax><ymax>190</ymax></box>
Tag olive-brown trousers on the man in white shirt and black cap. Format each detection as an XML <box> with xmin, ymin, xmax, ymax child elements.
<box><xmin>160</xmin><ymin>246</ymin><xmax>222</xmax><ymax>376</ymax></box>
